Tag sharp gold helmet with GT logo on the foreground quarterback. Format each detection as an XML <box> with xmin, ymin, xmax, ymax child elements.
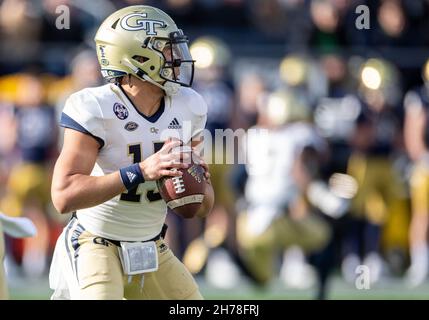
<box><xmin>95</xmin><ymin>5</ymin><xmax>194</xmax><ymax>95</ymax></box>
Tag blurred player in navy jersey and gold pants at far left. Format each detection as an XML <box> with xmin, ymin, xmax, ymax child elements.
<box><xmin>0</xmin><ymin>73</ymin><xmax>57</xmax><ymax>276</ymax></box>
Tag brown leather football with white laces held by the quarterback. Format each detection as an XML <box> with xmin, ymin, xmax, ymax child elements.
<box><xmin>157</xmin><ymin>163</ymin><xmax>206</xmax><ymax>219</ymax></box>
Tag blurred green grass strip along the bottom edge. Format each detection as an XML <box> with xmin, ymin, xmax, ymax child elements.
<box><xmin>10</xmin><ymin>277</ymin><xmax>429</xmax><ymax>300</ymax></box>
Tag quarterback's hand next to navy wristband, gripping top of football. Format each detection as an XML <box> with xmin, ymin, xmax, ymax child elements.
<box><xmin>140</xmin><ymin>140</ymin><xmax>190</xmax><ymax>181</ymax></box>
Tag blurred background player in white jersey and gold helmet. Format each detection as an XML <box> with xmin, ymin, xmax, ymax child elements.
<box><xmin>237</xmin><ymin>91</ymin><xmax>330</xmax><ymax>285</ymax></box>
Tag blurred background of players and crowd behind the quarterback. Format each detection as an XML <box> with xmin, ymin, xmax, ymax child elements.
<box><xmin>0</xmin><ymin>0</ymin><xmax>429</xmax><ymax>299</ymax></box>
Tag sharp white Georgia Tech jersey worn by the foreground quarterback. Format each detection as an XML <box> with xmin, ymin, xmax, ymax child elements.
<box><xmin>60</xmin><ymin>84</ymin><xmax>207</xmax><ymax>241</ymax></box>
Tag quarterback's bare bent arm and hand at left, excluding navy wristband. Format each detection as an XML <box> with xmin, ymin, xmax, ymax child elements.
<box><xmin>51</xmin><ymin>129</ymin><xmax>185</xmax><ymax>213</ymax></box>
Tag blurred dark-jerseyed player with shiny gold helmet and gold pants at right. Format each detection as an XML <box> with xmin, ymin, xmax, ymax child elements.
<box><xmin>342</xmin><ymin>59</ymin><xmax>406</xmax><ymax>283</ymax></box>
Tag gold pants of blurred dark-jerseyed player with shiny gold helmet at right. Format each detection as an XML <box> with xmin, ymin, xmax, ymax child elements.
<box><xmin>347</xmin><ymin>153</ymin><xmax>406</xmax><ymax>250</ymax></box>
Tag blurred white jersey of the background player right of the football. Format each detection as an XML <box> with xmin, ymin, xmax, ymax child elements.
<box><xmin>245</xmin><ymin>122</ymin><xmax>324</xmax><ymax>208</ymax></box>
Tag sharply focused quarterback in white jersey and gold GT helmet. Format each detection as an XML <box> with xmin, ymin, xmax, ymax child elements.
<box><xmin>50</xmin><ymin>5</ymin><xmax>214</xmax><ymax>299</ymax></box>
